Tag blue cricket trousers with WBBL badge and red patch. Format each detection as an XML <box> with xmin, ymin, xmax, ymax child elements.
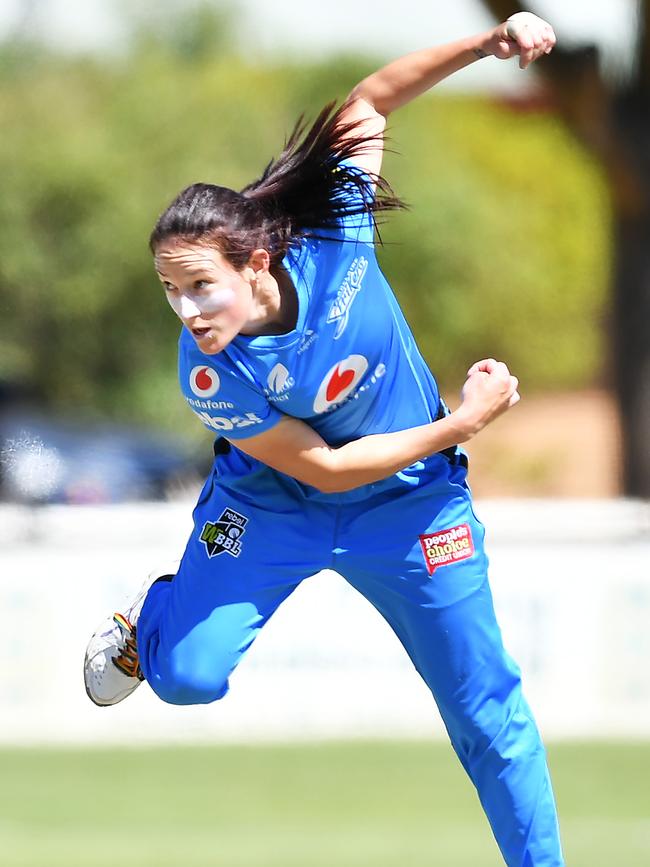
<box><xmin>138</xmin><ymin>449</ymin><xmax>564</xmax><ymax>867</ymax></box>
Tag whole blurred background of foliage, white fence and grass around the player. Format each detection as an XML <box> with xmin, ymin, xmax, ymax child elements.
<box><xmin>0</xmin><ymin>0</ymin><xmax>650</xmax><ymax>867</ymax></box>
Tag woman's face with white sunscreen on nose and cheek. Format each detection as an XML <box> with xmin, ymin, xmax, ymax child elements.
<box><xmin>155</xmin><ymin>238</ymin><xmax>255</xmax><ymax>355</ymax></box>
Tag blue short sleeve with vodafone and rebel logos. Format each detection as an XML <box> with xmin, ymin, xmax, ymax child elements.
<box><xmin>178</xmin><ymin>329</ymin><xmax>282</xmax><ymax>440</ymax></box>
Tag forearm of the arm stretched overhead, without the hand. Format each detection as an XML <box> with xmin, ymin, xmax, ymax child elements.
<box><xmin>351</xmin><ymin>33</ymin><xmax>491</xmax><ymax>116</ymax></box>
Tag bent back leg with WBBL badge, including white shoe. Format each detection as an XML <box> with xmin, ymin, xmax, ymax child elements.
<box><xmin>84</xmin><ymin>464</ymin><xmax>336</xmax><ymax>706</ymax></box>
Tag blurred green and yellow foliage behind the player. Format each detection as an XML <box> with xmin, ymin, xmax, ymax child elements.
<box><xmin>0</xmin><ymin>11</ymin><xmax>610</xmax><ymax>428</ymax></box>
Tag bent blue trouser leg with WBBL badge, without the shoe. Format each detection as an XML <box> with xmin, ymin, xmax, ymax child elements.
<box><xmin>137</xmin><ymin>472</ymin><xmax>334</xmax><ymax>704</ymax></box>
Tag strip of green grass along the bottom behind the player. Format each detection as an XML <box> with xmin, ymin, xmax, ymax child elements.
<box><xmin>0</xmin><ymin>742</ymin><xmax>650</xmax><ymax>867</ymax></box>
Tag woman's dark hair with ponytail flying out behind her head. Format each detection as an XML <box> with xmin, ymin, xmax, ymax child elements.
<box><xmin>149</xmin><ymin>103</ymin><xmax>403</xmax><ymax>268</ymax></box>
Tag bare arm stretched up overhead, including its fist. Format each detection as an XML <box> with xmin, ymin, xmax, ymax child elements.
<box><xmin>342</xmin><ymin>12</ymin><xmax>556</xmax><ymax>174</ymax></box>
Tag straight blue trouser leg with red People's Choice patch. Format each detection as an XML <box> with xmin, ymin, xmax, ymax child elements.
<box><xmin>336</xmin><ymin>459</ymin><xmax>564</xmax><ymax>867</ymax></box>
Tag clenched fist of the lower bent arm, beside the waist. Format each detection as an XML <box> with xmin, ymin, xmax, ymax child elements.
<box><xmin>452</xmin><ymin>358</ymin><xmax>520</xmax><ymax>439</ymax></box>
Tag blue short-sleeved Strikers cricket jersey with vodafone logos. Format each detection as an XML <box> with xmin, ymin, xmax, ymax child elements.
<box><xmin>179</xmin><ymin>167</ymin><xmax>439</xmax><ymax>464</ymax></box>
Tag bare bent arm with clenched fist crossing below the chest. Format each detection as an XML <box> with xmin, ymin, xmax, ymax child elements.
<box><xmin>234</xmin><ymin>359</ymin><xmax>519</xmax><ymax>493</ymax></box>
